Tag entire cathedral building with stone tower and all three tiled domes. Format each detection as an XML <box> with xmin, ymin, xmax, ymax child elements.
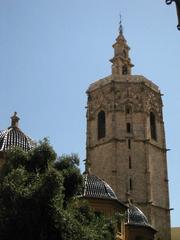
<box><xmin>0</xmin><ymin>23</ymin><xmax>171</xmax><ymax>240</ymax></box>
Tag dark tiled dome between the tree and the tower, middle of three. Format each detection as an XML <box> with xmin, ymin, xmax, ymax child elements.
<box><xmin>83</xmin><ymin>174</ymin><xmax>117</xmax><ymax>200</ymax></box>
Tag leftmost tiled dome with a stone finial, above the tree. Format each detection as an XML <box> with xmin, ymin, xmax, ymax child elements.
<box><xmin>0</xmin><ymin>112</ymin><xmax>35</xmax><ymax>151</ymax></box>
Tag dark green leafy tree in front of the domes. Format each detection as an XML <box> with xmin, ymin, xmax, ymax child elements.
<box><xmin>0</xmin><ymin>139</ymin><xmax>115</xmax><ymax>240</ymax></box>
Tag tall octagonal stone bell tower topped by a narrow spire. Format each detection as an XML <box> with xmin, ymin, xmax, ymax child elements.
<box><xmin>86</xmin><ymin>24</ymin><xmax>170</xmax><ymax>240</ymax></box>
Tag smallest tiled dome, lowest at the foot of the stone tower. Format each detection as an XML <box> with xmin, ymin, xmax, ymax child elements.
<box><xmin>125</xmin><ymin>205</ymin><xmax>150</xmax><ymax>226</ymax></box>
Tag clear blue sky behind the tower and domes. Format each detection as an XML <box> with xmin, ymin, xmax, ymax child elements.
<box><xmin>0</xmin><ymin>0</ymin><xmax>180</xmax><ymax>226</ymax></box>
